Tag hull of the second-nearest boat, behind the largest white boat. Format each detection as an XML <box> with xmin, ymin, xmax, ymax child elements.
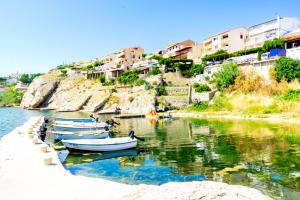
<box><xmin>52</xmin><ymin>132</ymin><xmax>109</xmax><ymax>140</ymax></box>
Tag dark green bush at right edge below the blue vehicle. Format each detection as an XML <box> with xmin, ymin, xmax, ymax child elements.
<box><xmin>274</xmin><ymin>57</ymin><xmax>300</xmax><ymax>82</ymax></box>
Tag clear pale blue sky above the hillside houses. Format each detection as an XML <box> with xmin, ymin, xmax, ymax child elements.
<box><xmin>0</xmin><ymin>0</ymin><xmax>300</xmax><ymax>75</ymax></box>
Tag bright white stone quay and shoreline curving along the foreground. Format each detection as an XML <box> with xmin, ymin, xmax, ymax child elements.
<box><xmin>0</xmin><ymin>118</ymin><xmax>271</xmax><ymax>200</ymax></box>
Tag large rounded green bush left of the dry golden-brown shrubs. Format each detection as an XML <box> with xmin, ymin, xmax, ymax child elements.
<box><xmin>214</xmin><ymin>63</ymin><xmax>239</xmax><ymax>91</ymax></box>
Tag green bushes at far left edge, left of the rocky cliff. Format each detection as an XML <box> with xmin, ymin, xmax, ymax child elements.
<box><xmin>0</xmin><ymin>86</ymin><xmax>23</xmax><ymax>106</ymax></box>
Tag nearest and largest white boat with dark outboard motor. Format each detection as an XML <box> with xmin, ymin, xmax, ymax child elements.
<box><xmin>62</xmin><ymin>137</ymin><xmax>137</xmax><ymax>151</ymax></box>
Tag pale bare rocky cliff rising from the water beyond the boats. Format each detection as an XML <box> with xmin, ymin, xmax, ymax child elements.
<box><xmin>21</xmin><ymin>74</ymin><xmax>155</xmax><ymax>113</ymax></box>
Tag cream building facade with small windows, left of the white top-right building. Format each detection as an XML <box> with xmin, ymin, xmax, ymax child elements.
<box><xmin>203</xmin><ymin>27</ymin><xmax>248</xmax><ymax>55</ymax></box>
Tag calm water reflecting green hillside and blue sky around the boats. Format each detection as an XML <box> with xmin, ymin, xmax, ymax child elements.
<box><xmin>0</xmin><ymin>109</ymin><xmax>300</xmax><ymax>199</ymax></box>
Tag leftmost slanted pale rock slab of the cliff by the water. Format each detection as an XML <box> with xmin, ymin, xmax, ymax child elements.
<box><xmin>21</xmin><ymin>76</ymin><xmax>60</xmax><ymax>108</ymax></box>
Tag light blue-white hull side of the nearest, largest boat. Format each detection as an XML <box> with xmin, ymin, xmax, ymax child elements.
<box><xmin>62</xmin><ymin>139</ymin><xmax>137</xmax><ymax>152</ymax></box>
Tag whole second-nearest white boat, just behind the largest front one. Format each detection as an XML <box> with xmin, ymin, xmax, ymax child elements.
<box><xmin>51</xmin><ymin>131</ymin><xmax>109</xmax><ymax>140</ymax></box>
